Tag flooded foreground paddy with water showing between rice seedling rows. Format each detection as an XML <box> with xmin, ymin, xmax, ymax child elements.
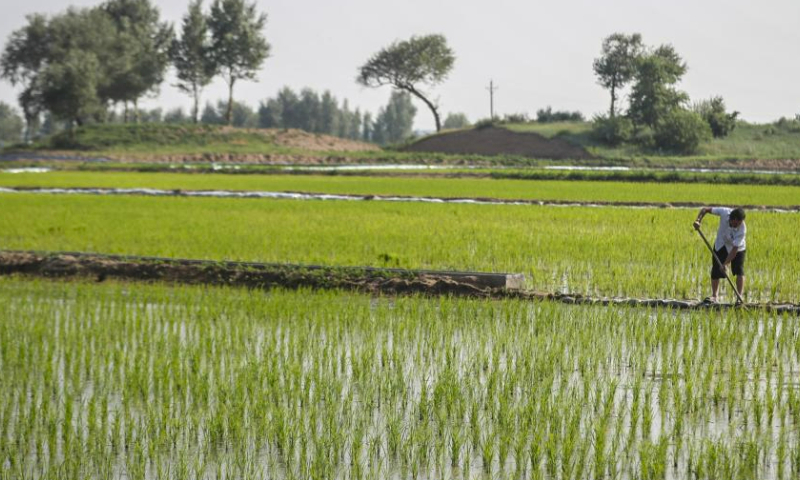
<box><xmin>0</xmin><ymin>278</ymin><xmax>800</xmax><ymax>480</ymax></box>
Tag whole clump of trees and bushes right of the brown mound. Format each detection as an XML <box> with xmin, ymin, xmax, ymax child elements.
<box><xmin>594</xmin><ymin>33</ymin><xmax>738</xmax><ymax>153</ymax></box>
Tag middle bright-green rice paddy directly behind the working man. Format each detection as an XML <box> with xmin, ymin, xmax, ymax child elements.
<box><xmin>0</xmin><ymin>194</ymin><xmax>800</xmax><ymax>301</ymax></box>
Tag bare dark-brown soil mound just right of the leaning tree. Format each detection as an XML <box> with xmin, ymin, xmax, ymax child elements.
<box><xmin>405</xmin><ymin>127</ymin><xmax>594</xmax><ymax>160</ymax></box>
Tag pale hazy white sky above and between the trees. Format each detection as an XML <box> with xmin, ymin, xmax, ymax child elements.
<box><xmin>0</xmin><ymin>0</ymin><xmax>800</xmax><ymax>129</ymax></box>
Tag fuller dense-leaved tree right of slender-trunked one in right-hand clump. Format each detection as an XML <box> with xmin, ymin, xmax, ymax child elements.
<box><xmin>628</xmin><ymin>45</ymin><xmax>689</xmax><ymax>127</ymax></box>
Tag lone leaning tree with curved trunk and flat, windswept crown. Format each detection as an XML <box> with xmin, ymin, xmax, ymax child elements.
<box><xmin>357</xmin><ymin>35</ymin><xmax>455</xmax><ymax>132</ymax></box>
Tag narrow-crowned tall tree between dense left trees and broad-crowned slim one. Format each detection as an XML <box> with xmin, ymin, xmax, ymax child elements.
<box><xmin>170</xmin><ymin>0</ymin><xmax>215</xmax><ymax>123</ymax></box>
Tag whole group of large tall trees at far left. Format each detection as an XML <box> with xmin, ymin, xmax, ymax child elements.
<box><xmin>0</xmin><ymin>0</ymin><xmax>270</xmax><ymax>139</ymax></box>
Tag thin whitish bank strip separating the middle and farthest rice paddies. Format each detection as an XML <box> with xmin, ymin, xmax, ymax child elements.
<box><xmin>0</xmin><ymin>187</ymin><xmax>800</xmax><ymax>213</ymax></box>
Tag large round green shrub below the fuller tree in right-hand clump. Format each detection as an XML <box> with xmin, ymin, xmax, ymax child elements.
<box><xmin>653</xmin><ymin>109</ymin><xmax>711</xmax><ymax>153</ymax></box>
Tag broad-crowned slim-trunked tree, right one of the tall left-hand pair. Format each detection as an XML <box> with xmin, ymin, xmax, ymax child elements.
<box><xmin>208</xmin><ymin>0</ymin><xmax>270</xmax><ymax>125</ymax></box>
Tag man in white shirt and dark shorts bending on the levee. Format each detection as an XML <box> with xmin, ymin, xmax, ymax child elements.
<box><xmin>694</xmin><ymin>207</ymin><xmax>747</xmax><ymax>303</ymax></box>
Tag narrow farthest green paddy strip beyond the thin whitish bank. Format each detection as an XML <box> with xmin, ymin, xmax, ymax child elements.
<box><xmin>0</xmin><ymin>171</ymin><xmax>800</xmax><ymax>206</ymax></box>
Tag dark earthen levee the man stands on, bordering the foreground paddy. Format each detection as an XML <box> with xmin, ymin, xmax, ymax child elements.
<box><xmin>0</xmin><ymin>250</ymin><xmax>800</xmax><ymax>315</ymax></box>
